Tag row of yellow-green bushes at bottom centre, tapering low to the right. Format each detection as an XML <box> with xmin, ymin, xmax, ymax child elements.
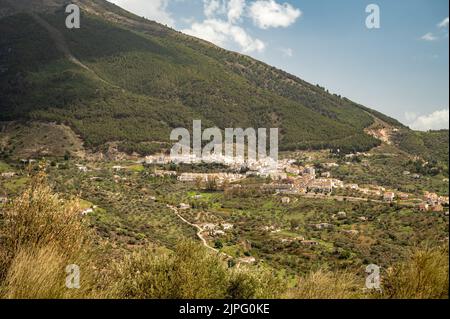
<box><xmin>111</xmin><ymin>241</ymin><xmax>283</xmax><ymax>299</ymax></box>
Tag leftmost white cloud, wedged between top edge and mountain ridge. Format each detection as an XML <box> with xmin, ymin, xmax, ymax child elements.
<box><xmin>108</xmin><ymin>0</ymin><xmax>175</xmax><ymax>27</ymax></box>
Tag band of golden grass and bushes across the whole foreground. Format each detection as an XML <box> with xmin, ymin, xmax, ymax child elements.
<box><xmin>0</xmin><ymin>173</ymin><xmax>448</xmax><ymax>298</ymax></box>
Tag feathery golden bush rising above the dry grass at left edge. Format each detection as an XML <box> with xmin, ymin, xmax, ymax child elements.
<box><xmin>1</xmin><ymin>173</ymin><xmax>86</xmax><ymax>258</ymax></box>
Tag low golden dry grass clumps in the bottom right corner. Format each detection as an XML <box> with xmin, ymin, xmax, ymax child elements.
<box><xmin>286</xmin><ymin>247</ymin><xmax>449</xmax><ymax>299</ymax></box>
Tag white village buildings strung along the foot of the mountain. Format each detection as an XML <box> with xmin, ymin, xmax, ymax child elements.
<box><xmin>145</xmin><ymin>153</ymin><xmax>448</xmax><ymax>211</ymax></box>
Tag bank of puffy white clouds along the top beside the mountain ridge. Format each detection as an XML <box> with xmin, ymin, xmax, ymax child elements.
<box><xmin>109</xmin><ymin>0</ymin><xmax>301</xmax><ymax>56</ymax></box>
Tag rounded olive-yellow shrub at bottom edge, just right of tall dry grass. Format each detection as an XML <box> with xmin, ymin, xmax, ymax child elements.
<box><xmin>112</xmin><ymin>242</ymin><xmax>226</xmax><ymax>299</ymax></box>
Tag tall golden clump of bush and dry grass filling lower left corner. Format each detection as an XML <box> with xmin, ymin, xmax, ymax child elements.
<box><xmin>0</xmin><ymin>173</ymin><xmax>101</xmax><ymax>298</ymax></box>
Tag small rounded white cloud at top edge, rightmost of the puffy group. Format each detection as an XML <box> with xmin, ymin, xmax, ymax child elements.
<box><xmin>249</xmin><ymin>0</ymin><xmax>302</xmax><ymax>29</ymax></box>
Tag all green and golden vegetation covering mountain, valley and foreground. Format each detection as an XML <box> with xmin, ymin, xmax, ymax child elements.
<box><xmin>0</xmin><ymin>0</ymin><xmax>449</xmax><ymax>298</ymax></box>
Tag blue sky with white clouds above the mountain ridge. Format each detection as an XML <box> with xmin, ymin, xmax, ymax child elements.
<box><xmin>109</xmin><ymin>0</ymin><xmax>449</xmax><ymax>130</ymax></box>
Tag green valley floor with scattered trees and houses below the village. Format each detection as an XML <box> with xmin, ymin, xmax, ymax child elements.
<box><xmin>0</xmin><ymin>144</ymin><xmax>448</xmax><ymax>280</ymax></box>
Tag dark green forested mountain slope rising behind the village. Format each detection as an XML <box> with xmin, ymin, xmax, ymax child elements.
<box><xmin>0</xmin><ymin>0</ymin><xmax>402</xmax><ymax>153</ymax></box>
